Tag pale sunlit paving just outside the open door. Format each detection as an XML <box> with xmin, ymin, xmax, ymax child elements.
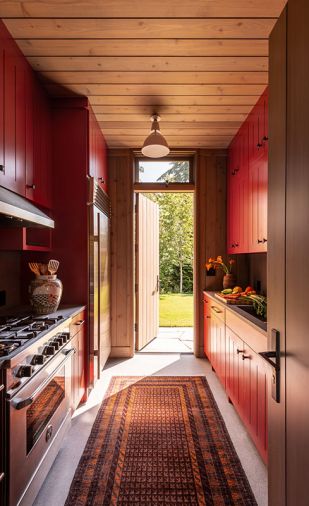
<box><xmin>140</xmin><ymin>327</ymin><xmax>193</xmax><ymax>353</ymax></box>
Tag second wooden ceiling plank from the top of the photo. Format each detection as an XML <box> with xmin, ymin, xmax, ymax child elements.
<box><xmin>4</xmin><ymin>17</ymin><xmax>276</xmax><ymax>39</ymax></box>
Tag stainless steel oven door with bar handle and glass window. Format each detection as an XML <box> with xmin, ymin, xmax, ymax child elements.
<box><xmin>7</xmin><ymin>349</ymin><xmax>75</xmax><ymax>506</ymax></box>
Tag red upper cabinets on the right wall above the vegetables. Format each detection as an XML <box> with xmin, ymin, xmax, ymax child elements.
<box><xmin>227</xmin><ymin>90</ymin><xmax>268</xmax><ymax>254</ymax></box>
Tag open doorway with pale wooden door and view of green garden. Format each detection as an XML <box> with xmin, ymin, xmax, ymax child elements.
<box><xmin>135</xmin><ymin>162</ymin><xmax>194</xmax><ymax>353</ymax></box>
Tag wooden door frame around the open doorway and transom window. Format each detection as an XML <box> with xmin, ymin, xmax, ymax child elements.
<box><xmin>133</xmin><ymin>156</ymin><xmax>195</xmax><ymax>356</ymax></box>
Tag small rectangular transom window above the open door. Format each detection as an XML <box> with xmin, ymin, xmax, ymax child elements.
<box><xmin>137</xmin><ymin>160</ymin><xmax>191</xmax><ymax>184</ymax></box>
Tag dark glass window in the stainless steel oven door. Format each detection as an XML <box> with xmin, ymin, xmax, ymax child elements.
<box><xmin>26</xmin><ymin>367</ymin><xmax>65</xmax><ymax>454</ymax></box>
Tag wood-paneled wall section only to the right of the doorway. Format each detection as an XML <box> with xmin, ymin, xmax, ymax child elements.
<box><xmin>194</xmin><ymin>150</ymin><xmax>227</xmax><ymax>357</ymax></box>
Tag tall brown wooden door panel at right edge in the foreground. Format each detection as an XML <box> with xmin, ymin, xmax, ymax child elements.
<box><xmin>268</xmin><ymin>0</ymin><xmax>309</xmax><ymax>506</ymax></box>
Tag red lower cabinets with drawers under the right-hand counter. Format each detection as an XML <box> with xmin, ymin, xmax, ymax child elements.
<box><xmin>204</xmin><ymin>294</ymin><xmax>268</xmax><ymax>462</ymax></box>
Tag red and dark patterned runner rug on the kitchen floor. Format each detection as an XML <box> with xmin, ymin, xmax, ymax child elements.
<box><xmin>66</xmin><ymin>376</ymin><xmax>256</xmax><ymax>506</ymax></box>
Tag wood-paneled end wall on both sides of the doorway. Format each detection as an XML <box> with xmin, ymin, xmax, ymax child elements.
<box><xmin>109</xmin><ymin>149</ymin><xmax>227</xmax><ymax>357</ymax></box>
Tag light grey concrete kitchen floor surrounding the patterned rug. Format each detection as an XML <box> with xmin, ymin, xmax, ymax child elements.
<box><xmin>33</xmin><ymin>353</ymin><xmax>267</xmax><ymax>506</ymax></box>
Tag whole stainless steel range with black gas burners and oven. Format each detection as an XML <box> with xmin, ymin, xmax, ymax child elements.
<box><xmin>0</xmin><ymin>312</ymin><xmax>79</xmax><ymax>506</ymax></box>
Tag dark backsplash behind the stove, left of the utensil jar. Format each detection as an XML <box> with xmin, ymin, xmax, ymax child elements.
<box><xmin>0</xmin><ymin>251</ymin><xmax>21</xmax><ymax>312</ymax></box>
